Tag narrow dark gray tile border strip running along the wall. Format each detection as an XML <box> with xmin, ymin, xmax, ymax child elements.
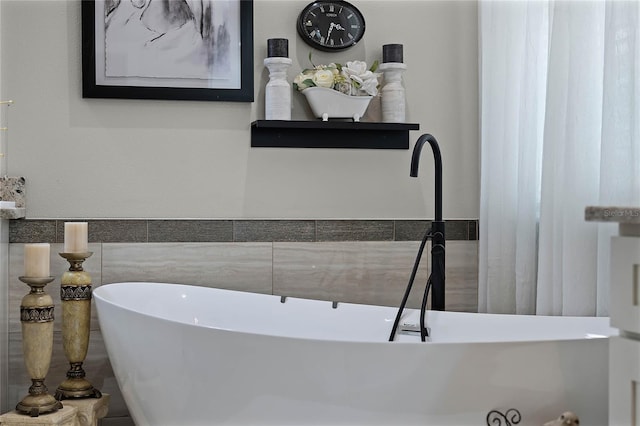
<box><xmin>9</xmin><ymin>219</ymin><xmax>478</xmax><ymax>243</ymax></box>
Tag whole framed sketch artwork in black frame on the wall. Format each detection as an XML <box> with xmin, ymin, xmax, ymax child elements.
<box><xmin>82</xmin><ymin>0</ymin><xmax>254</xmax><ymax>102</ymax></box>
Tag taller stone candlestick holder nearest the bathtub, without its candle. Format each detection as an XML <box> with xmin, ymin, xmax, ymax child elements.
<box><xmin>55</xmin><ymin>252</ymin><xmax>102</xmax><ymax>400</ymax></box>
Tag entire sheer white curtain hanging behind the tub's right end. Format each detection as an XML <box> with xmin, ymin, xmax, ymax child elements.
<box><xmin>478</xmin><ymin>0</ymin><xmax>640</xmax><ymax>315</ymax></box>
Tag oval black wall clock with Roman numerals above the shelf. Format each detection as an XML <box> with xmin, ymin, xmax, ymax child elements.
<box><xmin>297</xmin><ymin>1</ymin><xmax>364</xmax><ymax>51</ymax></box>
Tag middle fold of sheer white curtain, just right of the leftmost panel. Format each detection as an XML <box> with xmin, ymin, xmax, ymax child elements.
<box><xmin>536</xmin><ymin>2</ymin><xmax>605</xmax><ymax>315</ymax></box>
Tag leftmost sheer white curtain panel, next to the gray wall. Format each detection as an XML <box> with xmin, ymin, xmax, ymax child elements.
<box><xmin>478</xmin><ymin>2</ymin><xmax>549</xmax><ymax>314</ymax></box>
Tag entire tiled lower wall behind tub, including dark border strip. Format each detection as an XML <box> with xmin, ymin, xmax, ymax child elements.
<box><xmin>7</xmin><ymin>220</ymin><xmax>478</xmax><ymax>426</ymax></box>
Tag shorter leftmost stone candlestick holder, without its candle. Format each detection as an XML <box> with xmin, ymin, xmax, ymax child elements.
<box><xmin>16</xmin><ymin>277</ymin><xmax>62</xmax><ymax>417</ymax></box>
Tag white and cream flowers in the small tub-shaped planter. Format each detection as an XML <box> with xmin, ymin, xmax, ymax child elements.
<box><xmin>293</xmin><ymin>55</ymin><xmax>380</xmax><ymax>96</ymax></box>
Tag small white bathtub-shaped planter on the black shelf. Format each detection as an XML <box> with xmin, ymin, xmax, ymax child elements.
<box><xmin>302</xmin><ymin>87</ymin><xmax>373</xmax><ymax>121</ymax></box>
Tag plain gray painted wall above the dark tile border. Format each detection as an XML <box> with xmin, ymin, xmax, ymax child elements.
<box><xmin>0</xmin><ymin>0</ymin><xmax>479</xmax><ymax>219</ymax></box>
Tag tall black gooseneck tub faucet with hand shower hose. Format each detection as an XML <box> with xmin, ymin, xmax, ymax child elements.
<box><xmin>389</xmin><ymin>133</ymin><xmax>445</xmax><ymax>342</ymax></box>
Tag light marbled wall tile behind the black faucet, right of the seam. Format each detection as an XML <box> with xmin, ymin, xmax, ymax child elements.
<box><xmin>273</xmin><ymin>241</ymin><xmax>478</xmax><ymax>312</ymax></box>
